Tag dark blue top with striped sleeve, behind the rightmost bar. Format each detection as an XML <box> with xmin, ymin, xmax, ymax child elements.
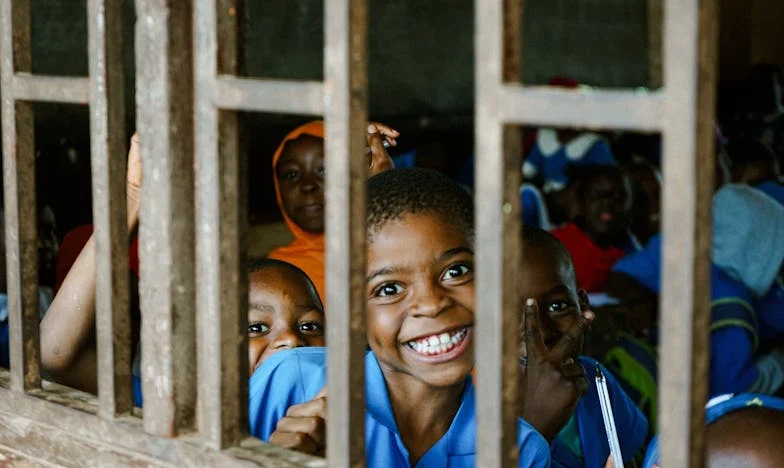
<box><xmin>613</xmin><ymin>235</ymin><xmax>784</xmax><ymax>396</ymax></box>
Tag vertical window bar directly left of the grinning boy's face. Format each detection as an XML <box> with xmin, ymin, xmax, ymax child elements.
<box><xmin>324</xmin><ymin>0</ymin><xmax>368</xmax><ymax>467</ymax></box>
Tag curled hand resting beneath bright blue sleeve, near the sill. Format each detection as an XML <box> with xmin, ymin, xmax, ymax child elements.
<box><xmin>269</xmin><ymin>387</ymin><xmax>327</xmax><ymax>456</ymax></box>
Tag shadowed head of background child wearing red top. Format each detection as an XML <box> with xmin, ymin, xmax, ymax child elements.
<box><xmin>577</xmin><ymin>173</ymin><xmax>631</xmax><ymax>247</ymax></box>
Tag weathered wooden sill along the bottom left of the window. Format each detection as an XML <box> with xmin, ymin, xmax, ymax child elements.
<box><xmin>0</xmin><ymin>369</ymin><xmax>326</xmax><ymax>468</ymax></box>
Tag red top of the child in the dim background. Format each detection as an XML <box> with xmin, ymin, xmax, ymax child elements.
<box><xmin>552</xmin><ymin>223</ymin><xmax>626</xmax><ymax>292</ymax></box>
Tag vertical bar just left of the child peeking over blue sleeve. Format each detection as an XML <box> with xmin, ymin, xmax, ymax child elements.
<box><xmin>194</xmin><ymin>0</ymin><xmax>248</xmax><ymax>449</ymax></box>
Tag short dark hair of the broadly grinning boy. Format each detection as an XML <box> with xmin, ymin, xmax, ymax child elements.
<box><xmin>367</xmin><ymin>168</ymin><xmax>474</xmax><ymax>243</ymax></box>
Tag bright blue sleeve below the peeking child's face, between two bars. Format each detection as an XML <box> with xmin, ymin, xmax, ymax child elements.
<box><xmin>248</xmin><ymin>347</ymin><xmax>327</xmax><ymax>441</ymax></box>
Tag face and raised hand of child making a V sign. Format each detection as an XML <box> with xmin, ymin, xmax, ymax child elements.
<box><xmin>519</xmin><ymin>244</ymin><xmax>594</xmax><ymax>442</ymax></box>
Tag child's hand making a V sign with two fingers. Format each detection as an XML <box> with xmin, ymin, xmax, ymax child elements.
<box><xmin>518</xmin><ymin>299</ymin><xmax>593</xmax><ymax>441</ymax></box>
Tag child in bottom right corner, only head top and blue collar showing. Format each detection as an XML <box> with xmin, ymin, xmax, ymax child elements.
<box><xmin>643</xmin><ymin>393</ymin><xmax>784</xmax><ymax>468</ymax></box>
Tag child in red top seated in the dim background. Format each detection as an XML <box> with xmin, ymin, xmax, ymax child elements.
<box><xmin>553</xmin><ymin>166</ymin><xmax>634</xmax><ymax>292</ymax></box>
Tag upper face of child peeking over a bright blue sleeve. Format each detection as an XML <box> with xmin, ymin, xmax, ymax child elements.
<box><xmin>248</xmin><ymin>267</ymin><xmax>325</xmax><ymax>375</ymax></box>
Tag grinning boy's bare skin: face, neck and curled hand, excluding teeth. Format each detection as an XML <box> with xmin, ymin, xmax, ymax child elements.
<box><xmin>270</xmin><ymin>214</ymin><xmax>474</xmax><ymax>465</ymax></box>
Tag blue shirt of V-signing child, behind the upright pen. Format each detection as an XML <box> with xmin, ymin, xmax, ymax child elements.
<box><xmin>550</xmin><ymin>356</ymin><xmax>648</xmax><ymax>468</ymax></box>
